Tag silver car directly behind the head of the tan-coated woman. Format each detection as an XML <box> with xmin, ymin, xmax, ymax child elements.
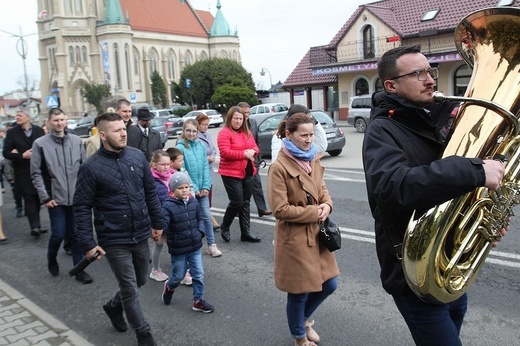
<box><xmin>249</xmin><ymin>110</ymin><xmax>347</xmax><ymax>157</ymax></box>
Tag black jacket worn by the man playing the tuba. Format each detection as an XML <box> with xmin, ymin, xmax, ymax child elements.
<box><xmin>363</xmin><ymin>93</ymin><xmax>485</xmax><ymax>295</ymax></box>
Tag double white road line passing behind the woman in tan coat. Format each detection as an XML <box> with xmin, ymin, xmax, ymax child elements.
<box><xmin>211</xmin><ymin>207</ymin><xmax>520</xmax><ymax>268</ymax></box>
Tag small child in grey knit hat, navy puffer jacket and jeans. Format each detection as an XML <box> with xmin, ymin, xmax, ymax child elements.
<box><xmin>162</xmin><ymin>172</ymin><xmax>213</xmax><ymax>313</ymax></box>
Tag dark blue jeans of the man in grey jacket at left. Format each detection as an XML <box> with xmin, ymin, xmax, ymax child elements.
<box><xmin>47</xmin><ymin>205</ymin><xmax>83</xmax><ymax>265</ymax></box>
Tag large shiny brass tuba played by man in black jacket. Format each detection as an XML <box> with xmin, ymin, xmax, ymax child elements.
<box><xmin>402</xmin><ymin>7</ymin><xmax>520</xmax><ymax>303</ymax></box>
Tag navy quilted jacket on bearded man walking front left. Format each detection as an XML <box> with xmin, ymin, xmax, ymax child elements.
<box><xmin>74</xmin><ymin>147</ymin><xmax>164</xmax><ymax>252</ymax></box>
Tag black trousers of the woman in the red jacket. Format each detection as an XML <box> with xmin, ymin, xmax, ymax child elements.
<box><xmin>221</xmin><ymin>176</ymin><xmax>253</xmax><ymax>233</ymax></box>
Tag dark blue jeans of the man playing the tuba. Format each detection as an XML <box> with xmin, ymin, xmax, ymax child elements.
<box><xmin>393</xmin><ymin>294</ymin><xmax>468</xmax><ymax>346</ymax></box>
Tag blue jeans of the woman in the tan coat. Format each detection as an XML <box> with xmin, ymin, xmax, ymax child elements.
<box><xmin>286</xmin><ymin>276</ymin><xmax>338</xmax><ymax>339</ymax></box>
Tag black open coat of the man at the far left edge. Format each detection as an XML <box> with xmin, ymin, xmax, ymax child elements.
<box><xmin>2</xmin><ymin>125</ymin><xmax>45</xmax><ymax>196</ymax></box>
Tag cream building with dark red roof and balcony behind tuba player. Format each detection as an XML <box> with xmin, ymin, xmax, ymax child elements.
<box><xmin>283</xmin><ymin>0</ymin><xmax>520</xmax><ymax>119</ymax></box>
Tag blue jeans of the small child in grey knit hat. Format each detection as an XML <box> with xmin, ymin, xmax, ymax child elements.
<box><xmin>168</xmin><ymin>249</ymin><xmax>204</xmax><ymax>300</ymax></box>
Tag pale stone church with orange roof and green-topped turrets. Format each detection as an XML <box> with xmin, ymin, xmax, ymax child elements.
<box><xmin>37</xmin><ymin>0</ymin><xmax>241</xmax><ymax>116</ymax></box>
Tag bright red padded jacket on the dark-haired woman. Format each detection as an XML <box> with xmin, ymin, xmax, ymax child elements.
<box><xmin>217</xmin><ymin>127</ymin><xmax>260</xmax><ymax>179</ymax></box>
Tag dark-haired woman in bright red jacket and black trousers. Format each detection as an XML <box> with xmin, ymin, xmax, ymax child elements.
<box><xmin>217</xmin><ymin>106</ymin><xmax>260</xmax><ymax>243</ymax></box>
